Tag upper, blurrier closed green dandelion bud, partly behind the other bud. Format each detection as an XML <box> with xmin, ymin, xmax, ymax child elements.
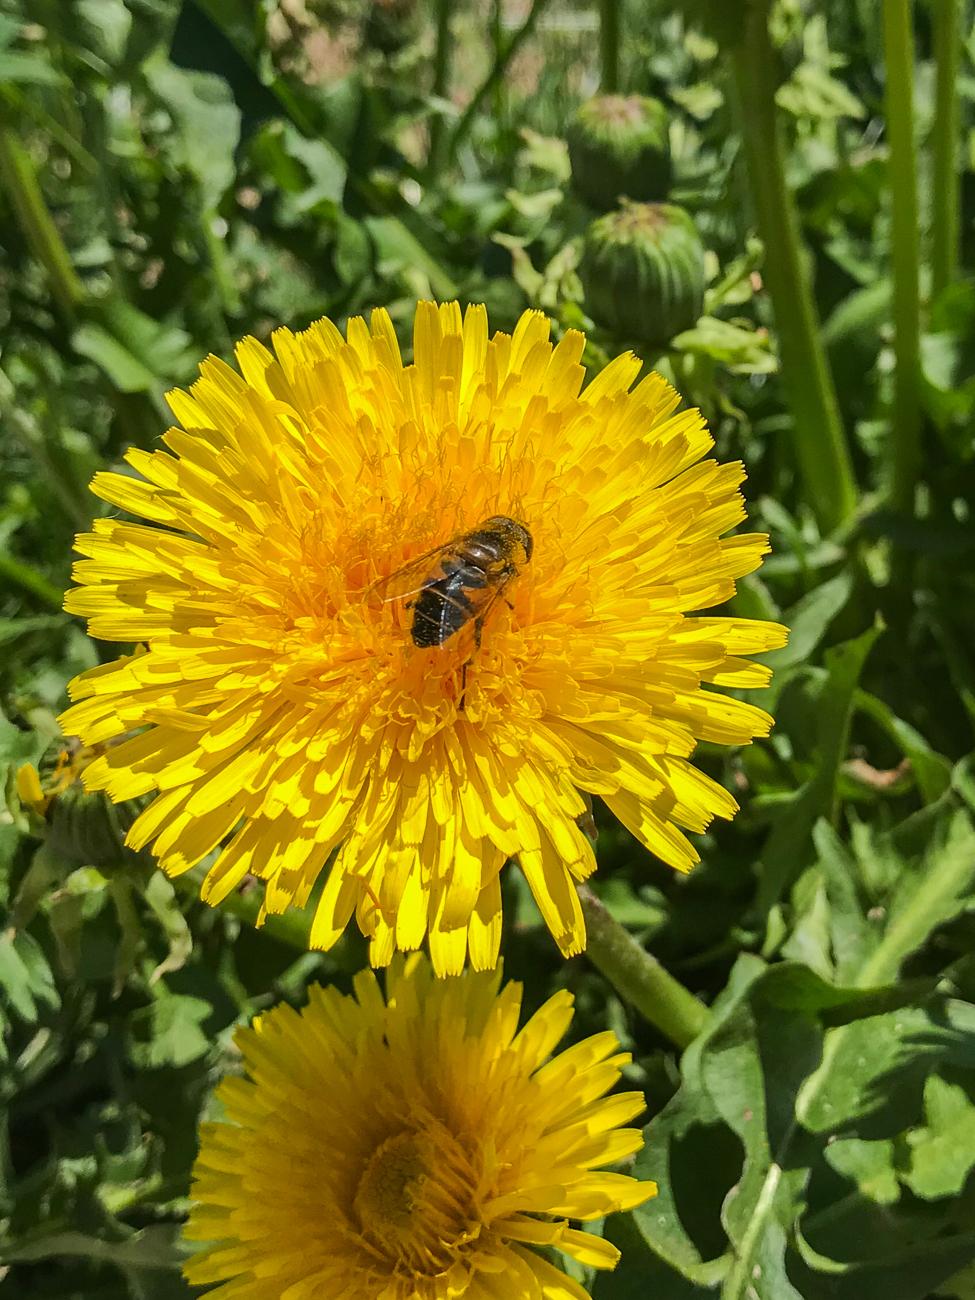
<box><xmin>567</xmin><ymin>95</ymin><xmax>672</xmax><ymax>212</ymax></box>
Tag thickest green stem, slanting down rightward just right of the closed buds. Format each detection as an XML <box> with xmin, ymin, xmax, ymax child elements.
<box><xmin>732</xmin><ymin>0</ymin><xmax>857</xmax><ymax>532</ymax></box>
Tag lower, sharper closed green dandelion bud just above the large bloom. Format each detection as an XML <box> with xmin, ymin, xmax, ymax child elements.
<box><xmin>579</xmin><ymin>202</ymin><xmax>705</xmax><ymax>347</ymax></box>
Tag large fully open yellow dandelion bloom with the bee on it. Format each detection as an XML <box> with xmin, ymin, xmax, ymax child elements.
<box><xmin>61</xmin><ymin>303</ymin><xmax>784</xmax><ymax>974</ymax></box>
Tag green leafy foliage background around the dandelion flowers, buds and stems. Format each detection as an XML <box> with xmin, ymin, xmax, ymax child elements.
<box><xmin>0</xmin><ymin>0</ymin><xmax>975</xmax><ymax>1300</ymax></box>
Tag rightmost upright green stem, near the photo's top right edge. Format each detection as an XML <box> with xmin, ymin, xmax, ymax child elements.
<box><xmin>931</xmin><ymin>0</ymin><xmax>962</xmax><ymax>298</ymax></box>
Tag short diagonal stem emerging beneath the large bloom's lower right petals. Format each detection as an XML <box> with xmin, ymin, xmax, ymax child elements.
<box><xmin>579</xmin><ymin>885</ymin><xmax>707</xmax><ymax>1049</ymax></box>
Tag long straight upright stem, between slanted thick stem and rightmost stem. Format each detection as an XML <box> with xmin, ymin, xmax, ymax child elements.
<box><xmin>884</xmin><ymin>0</ymin><xmax>920</xmax><ymax>514</ymax></box>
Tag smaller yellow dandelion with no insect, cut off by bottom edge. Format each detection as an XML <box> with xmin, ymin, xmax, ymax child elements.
<box><xmin>185</xmin><ymin>954</ymin><xmax>657</xmax><ymax>1300</ymax></box>
